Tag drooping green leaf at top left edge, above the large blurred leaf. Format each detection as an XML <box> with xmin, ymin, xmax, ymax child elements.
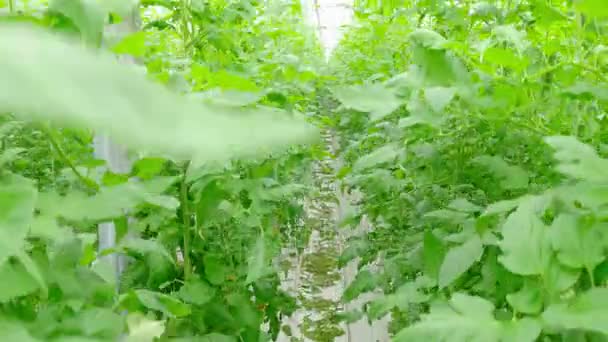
<box><xmin>49</xmin><ymin>0</ymin><xmax>105</xmax><ymax>46</ymax></box>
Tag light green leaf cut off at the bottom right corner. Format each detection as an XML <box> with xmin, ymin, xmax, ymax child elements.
<box><xmin>542</xmin><ymin>288</ymin><xmax>608</xmax><ymax>334</ymax></box>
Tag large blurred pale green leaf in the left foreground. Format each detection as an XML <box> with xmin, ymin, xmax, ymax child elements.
<box><xmin>0</xmin><ymin>23</ymin><xmax>318</xmax><ymax>161</ymax></box>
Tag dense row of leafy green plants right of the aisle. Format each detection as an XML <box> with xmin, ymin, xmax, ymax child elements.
<box><xmin>324</xmin><ymin>0</ymin><xmax>608</xmax><ymax>341</ymax></box>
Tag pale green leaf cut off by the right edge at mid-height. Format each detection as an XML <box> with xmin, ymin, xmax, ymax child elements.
<box><xmin>545</xmin><ymin>136</ymin><xmax>608</xmax><ymax>182</ymax></box>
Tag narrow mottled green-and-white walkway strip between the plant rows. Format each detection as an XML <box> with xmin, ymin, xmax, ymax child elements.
<box><xmin>279</xmin><ymin>129</ymin><xmax>348</xmax><ymax>342</ymax></box>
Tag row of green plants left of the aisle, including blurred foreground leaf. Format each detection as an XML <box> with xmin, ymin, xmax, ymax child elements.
<box><xmin>0</xmin><ymin>0</ymin><xmax>332</xmax><ymax>342</ymax></box>
